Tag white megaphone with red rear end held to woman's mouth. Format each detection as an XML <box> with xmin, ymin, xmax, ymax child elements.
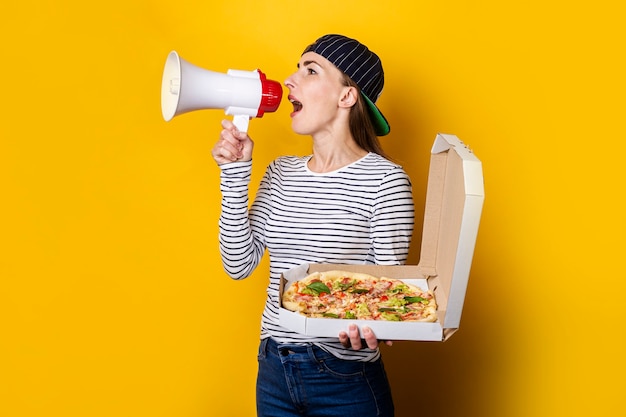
<box><xmin>161</xmin><ymin>51</ymin><xmax>283</xmax><ymax>132</ymax></box>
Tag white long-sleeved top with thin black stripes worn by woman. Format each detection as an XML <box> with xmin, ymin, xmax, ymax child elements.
<box><xmin>219</xmin><ymin>153</ymin><xmax>414</xmax><ymax>361</ymax></box>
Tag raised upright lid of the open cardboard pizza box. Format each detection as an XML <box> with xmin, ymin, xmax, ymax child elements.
<box><xmin>418</xmin><ymin>134</ymin><xmax>484</xmax><ymax>328</ymax></box>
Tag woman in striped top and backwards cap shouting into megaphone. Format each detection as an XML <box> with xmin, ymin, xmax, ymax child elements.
<box><xmin>212</xmin><ymin>35</ymin><xmax>414</xmax><ymax>416</ymax></box>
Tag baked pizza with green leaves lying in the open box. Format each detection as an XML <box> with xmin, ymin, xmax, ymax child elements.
<box><xmin>282</xmin><ymin>270</ymin><xmax>437</xmax><ymax>322</ymax></box>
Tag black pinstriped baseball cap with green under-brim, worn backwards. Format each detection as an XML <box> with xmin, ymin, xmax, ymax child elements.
<box><xmin>302</xmin><ymin>35</ymin><xmax>391</xmax><ymax>136</ymax></box>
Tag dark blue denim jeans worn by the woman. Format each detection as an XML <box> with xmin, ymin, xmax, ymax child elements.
<box><xmin>256</xmin><ymin>338</ymin><xmax>394</xmax><ymax>417</ymax></box>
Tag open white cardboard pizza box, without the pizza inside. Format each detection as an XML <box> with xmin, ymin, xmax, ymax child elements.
<box><xmin>279</xmin><ymin>134</ymin><xmax>485</xmax><ymax>341</ymax></box>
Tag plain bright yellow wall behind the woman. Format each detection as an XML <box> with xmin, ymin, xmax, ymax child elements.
<box><xmin>0</xmin><ymin>0</ymin><xmax>626</xmax><ymax>417</ymax></box>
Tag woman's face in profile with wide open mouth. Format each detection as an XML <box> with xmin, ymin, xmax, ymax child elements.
<box><xmin>285</xmin><ymin>52</ymin><xmax>349</xmax><ymax>135</ymax></box>
